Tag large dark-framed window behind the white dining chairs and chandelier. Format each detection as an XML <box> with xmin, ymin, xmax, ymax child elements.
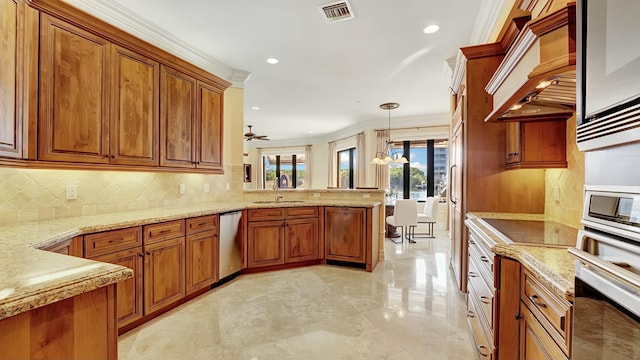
<box><xmin>389</xmin><ymin>139</ymin><xmax>448</xmax><ymax>201</ymax></box>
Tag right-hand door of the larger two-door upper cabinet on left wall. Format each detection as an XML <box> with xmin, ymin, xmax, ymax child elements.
<box><xmin>110</xmin><ymin>45</ymin><xmax>159</xmax><ymax>166</ymax></box>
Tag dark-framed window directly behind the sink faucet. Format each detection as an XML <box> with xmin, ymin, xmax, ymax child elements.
<box><xmin>262</xmin><ymin>154</ymin><xmax>305</xmax><ymax>189</ymax></box>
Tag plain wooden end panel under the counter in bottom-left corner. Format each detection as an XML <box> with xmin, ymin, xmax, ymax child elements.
<box><xmin>0</xmin><ymin>284</ymin><xmax>118</xmax><ymax>360</ymax></box>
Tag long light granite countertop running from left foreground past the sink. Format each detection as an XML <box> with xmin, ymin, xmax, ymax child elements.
<box><xmin>0</xmin><ymin>199</ymin><xmax>380</xmax><ymax>319</ymax></box>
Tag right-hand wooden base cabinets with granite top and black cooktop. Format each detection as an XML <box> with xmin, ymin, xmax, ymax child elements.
<box><xmin>465</xmin><ymin>213</ymin><xmax>577</xmax><ymax>359</ymax></box>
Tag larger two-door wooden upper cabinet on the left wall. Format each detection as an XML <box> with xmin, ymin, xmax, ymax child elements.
<box><xmin>38</xmin><ymin>15</ymin><xmax>159</xmax><ymax>166</ymax></box>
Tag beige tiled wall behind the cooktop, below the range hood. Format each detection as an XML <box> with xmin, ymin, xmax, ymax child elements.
<box><xmin>544</xmin><ymin>116</ymin><xmax>584</xmax><ymax>228</ymax></box>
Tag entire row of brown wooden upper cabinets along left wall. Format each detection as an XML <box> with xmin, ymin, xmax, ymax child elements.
<box><xmin>0</xmin><ymin>0</ymin><xmax>230</xmax><ymax>173</ymax></box>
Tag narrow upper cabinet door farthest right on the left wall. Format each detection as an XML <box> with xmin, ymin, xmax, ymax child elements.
<box><xmin>196</xmin><ymin>82</ymin><xmax>223</xmax><ymax>169</ymax></box>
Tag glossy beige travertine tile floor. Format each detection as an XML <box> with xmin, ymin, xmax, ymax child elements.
<box><xmin>118</xmin><ymin>225</ymin><xmax>476</xmax><ymax>360</ymax></box>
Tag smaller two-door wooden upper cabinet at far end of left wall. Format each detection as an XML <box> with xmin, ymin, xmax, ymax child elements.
<box><xmin>160</xmin><ymin>66</ymin><xmax>222</xmax><ymax>169</ymax></box>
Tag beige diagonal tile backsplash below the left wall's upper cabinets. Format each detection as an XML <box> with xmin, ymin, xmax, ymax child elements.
<box><xmin>0</xmin><ymin>166</ymin><xmax>242</xmax><ymax>224</ymax></box>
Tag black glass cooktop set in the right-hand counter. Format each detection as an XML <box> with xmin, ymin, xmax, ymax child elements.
<box><xmin>482</xmin><ymin>218</ymin><xmax>578</xmax><ymax>247</ymax></box>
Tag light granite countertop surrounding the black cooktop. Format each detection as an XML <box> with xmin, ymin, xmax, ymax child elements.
<box><xmin>465</xmin><ymin>213</ymin><xmax>577</xmax><ymax>301</ymax></box>
